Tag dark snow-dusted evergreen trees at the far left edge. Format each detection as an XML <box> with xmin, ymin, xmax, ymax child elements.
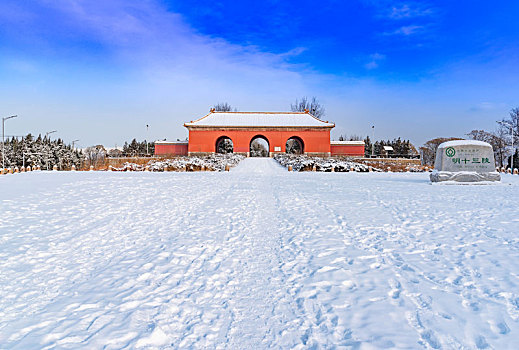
<box><xmin>0</xmin><ymin>134</ymin><xmax>84</xmax><ymax>170</ymax></box>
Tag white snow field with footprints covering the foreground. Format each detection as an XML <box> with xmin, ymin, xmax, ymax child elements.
<box><xmin>0</xmin><ymin>159</ymin><xmax>519</xmax><ymax>349</ymax></box>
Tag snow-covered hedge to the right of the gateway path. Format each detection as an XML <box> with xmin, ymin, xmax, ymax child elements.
<box><xmin>274</xmin><ymin>154</ymin><xmax>380</xmax><ymax>172</ymax></box>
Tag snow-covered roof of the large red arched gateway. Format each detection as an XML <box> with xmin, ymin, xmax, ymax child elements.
<box><xmin>184</xmin><ymin>111</ymin><xmax>335</xmax><ymax>128</ymax></box>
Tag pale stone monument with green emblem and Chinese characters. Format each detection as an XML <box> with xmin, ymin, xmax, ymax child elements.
<box><xmin>430</xmin><ymin>140</ymin><xmax>501</xmax><ymax>182</ymax></box>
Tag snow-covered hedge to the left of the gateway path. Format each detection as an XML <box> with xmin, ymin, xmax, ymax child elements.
<box><xmin>112</xmin><ymin>154</ymin><xmax>245</xmax><ymax>171</ymax></box>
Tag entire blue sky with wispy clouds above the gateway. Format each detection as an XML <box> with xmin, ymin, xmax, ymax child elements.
<box><xmin>0</xmin><ymin>0</ymin><xmax>519</xmax><ymax>147</ymax></box>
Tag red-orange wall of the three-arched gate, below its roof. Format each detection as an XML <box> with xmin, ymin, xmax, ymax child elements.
<box><xmin>188</xmin><ymin>128</ymin><xmax>330</xmax><ymax>155</ymax></box>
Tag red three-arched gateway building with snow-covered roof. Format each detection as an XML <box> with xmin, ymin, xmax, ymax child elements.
<box><xmin>184</xmin><ymin>110</ymin><xmax>335</xmax><ymax>156</ymax></box>
